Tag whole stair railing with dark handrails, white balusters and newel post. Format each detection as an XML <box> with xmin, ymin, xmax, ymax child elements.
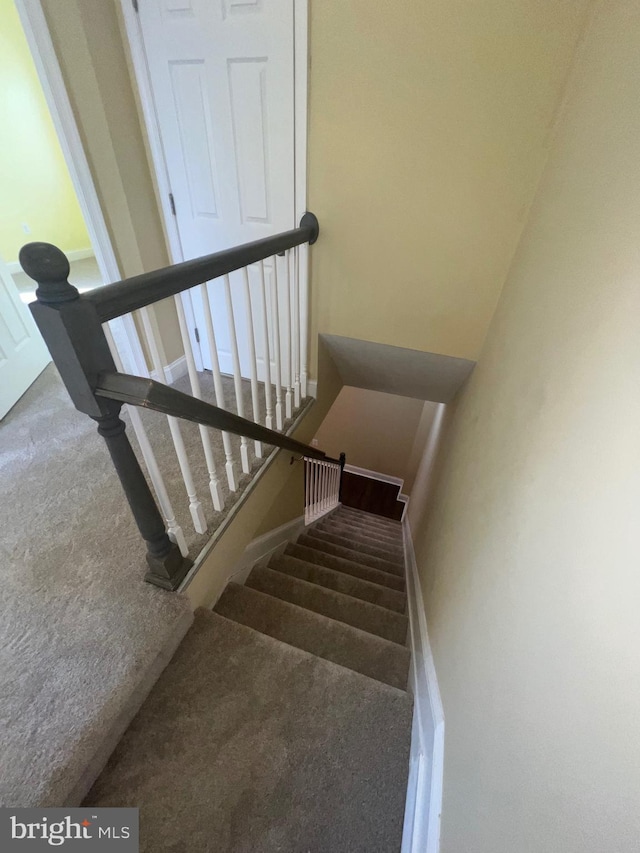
<box><xmin>20</xmin><ymin>213</ymin><xmax>341</xmax><ymax>589</ymax></box>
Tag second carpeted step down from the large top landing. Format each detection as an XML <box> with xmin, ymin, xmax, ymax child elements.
<box><xmin>245</xmin><ymin>566</ymin><xmax>408</xmax><ymax>645</ymax></box>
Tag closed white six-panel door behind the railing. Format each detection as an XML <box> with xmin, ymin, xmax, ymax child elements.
<box><xmin>139</xmin><ymin>0</ymin><xmax>297</xmax><ymax>381</ymax></box>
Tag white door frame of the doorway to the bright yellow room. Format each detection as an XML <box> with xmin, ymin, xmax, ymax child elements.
<box><xmin>15</xmin><ymin>0</ymin><xmax>149</xmax><ymax>376</ymax></box>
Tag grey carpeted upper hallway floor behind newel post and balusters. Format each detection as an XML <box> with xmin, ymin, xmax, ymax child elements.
<box><xmin>0</xmin><ymin>365</ymin><xmax>308</xmax><ymax>806</ymax></box>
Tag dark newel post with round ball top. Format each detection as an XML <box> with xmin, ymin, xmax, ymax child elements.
<box><xmin>20</xmin><ymin>243</ymin><xmax>191</xmax><ymax>589</ymax></box>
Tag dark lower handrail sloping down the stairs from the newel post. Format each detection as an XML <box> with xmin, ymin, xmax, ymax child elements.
<box><xmin>95</xmin><ymin>372</ymin><xmax>340</xmax><ymax>465</ymax></box>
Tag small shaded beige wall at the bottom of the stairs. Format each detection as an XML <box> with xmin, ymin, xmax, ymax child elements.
<box><xmin>315</xmin><ymin>385</ymin><xmax>436</xmax><ymax>480</ymax></box>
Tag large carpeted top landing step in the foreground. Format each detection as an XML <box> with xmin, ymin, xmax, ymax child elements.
<box><xmin>85</xmin><ymin>604</ymin><xmax>412</xmax><ymax>853</ymax></box>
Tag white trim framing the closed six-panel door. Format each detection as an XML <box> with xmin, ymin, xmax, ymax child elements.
<box><xmin>120</xmin><ymin>0</ymin><xmax>309</xmax><ymax>370</ymax></box>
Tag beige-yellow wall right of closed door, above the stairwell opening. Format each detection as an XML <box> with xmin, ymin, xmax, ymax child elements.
<box><xmin>309</xmin><ymin>0</ymin><xmax>589</xmax><ymax>362</ymax></box>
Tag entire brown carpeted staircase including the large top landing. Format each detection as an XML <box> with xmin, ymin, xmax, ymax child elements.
<box><xmin>85</xmin><ymin>507</ymin><xmax>413</xmax><ymax>853</ymax></box>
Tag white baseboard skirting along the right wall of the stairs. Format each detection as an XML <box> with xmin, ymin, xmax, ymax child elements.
<box><xmin>402</xmin><ymin>521</ymin><xmax>444</xmax><ymax>853</ymax></box>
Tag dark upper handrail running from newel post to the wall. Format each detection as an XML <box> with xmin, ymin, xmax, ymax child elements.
<box><xmin>84</xmin><ymin>213</ymin><xmax>319</xmax><ymax>323</ymax></box>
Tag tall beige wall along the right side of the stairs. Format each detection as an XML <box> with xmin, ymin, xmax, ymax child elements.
<box><xmin>414</xmin><ymin>0</ymin><xmax>640</xmax><ymax>853</ymax></box>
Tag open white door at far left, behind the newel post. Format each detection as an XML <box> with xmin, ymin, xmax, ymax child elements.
<box><xmin>0</xmin><ymin>259</ymin><xmax>51</xmax><ymax>418</ymax></box>
